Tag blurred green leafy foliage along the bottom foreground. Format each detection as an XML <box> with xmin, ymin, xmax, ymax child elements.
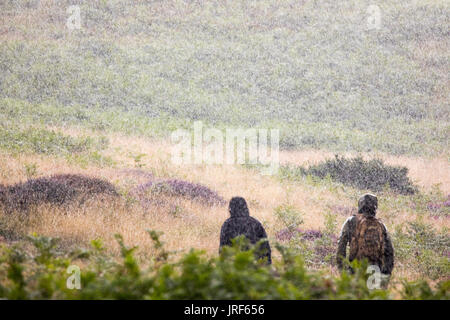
<box><xmin>0</xmin><ymin>231</ymin><xmax>450</xmax><ymax>299</ymax></box>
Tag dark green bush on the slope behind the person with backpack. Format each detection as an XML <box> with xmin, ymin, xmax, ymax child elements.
<box><xmin>280</xmin><ymin>155</ymin><xmax>417</xmax><ymax>195</ymax></box>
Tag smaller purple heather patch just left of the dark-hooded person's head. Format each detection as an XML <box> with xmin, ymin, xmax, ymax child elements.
<box><xmin>135</xmin><ymin>179</ymin><xmax>226</xmax><ymax>205</ymax></box>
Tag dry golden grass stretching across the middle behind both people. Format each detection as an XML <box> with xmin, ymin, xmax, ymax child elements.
<box><xmin>0</xmin><ymin>129</ymin><xmax>450</xmax><ymax>278</ymax></box>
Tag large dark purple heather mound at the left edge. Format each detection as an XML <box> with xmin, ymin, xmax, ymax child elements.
<box><xmin>0</xmin><ymin>174</ymin><xmax>118</xmax><ymax>211</ymax></box>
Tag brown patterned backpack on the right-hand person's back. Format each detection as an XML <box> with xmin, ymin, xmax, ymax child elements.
<box><xmin>349</xmin><ymin>214</ymin><xmax>385</xmax><ymax>267</ymax></box>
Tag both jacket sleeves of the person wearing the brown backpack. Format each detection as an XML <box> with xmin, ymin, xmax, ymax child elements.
<box><xmin>336</xmin><ymin>215</ymin><xmax>394</xmax><ymax>274</ymax></box>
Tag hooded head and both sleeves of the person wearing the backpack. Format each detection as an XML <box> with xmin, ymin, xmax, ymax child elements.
<box><xmin>336</xmin><ymin>194</ymin><xmax>394</xmax><ymax>275</ymax></box>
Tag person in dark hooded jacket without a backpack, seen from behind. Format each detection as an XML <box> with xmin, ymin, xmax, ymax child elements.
<box><xmin>219</xmin><ymin>197</ymin><xmax>272</xmax><ymax>264</ymax></box>
